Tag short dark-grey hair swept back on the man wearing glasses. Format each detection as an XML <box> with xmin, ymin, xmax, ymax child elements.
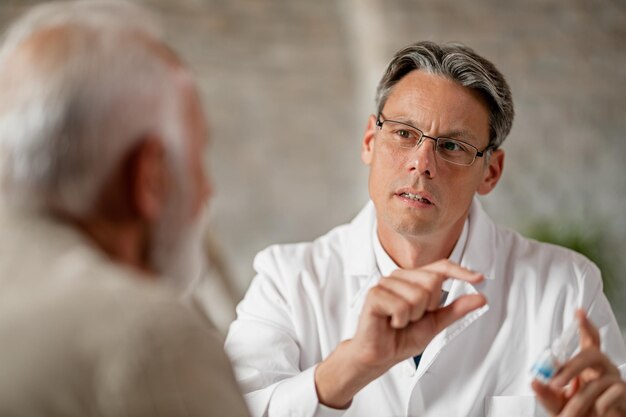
<box><xmin>376</xmin><ymin>42</ymin><xmax>514</xmax><ymax>149</ymax></box>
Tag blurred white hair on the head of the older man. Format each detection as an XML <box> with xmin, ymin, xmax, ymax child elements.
<box><xmin>0</xmin><ymin>0</ymin><xmax>184</xmax><ymax>216</ymax></box>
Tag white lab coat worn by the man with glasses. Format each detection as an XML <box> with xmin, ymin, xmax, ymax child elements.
<box><xmin>226</xmin><ymin>200</ymin><xmax>626</xmax><ymax>417</ymax></box>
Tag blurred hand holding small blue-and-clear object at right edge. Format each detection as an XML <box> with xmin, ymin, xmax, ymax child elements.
<box><xmin>532</xmin><ymin>310</ymin><xmax>626</xmax><ymax>417</ymax></box>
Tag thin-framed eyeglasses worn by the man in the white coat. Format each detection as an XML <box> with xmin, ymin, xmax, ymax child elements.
<box><xmin>376</xmin><ymin>114</ymin><xmax>491</xmax><ymax>166</ymax></box>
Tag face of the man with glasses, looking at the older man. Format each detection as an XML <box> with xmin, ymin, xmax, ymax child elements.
<box><xmin>361</xmin><ymin>70</ymin><xmax>503</xmax><ymax>241</ymax></box>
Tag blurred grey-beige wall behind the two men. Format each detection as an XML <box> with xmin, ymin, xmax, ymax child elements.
<box><xmin>0</xmin><ymin>0</ymin><xmax>626</xmax><ymax>334</ymax></box>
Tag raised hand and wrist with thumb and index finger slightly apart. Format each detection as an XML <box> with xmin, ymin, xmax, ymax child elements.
<box><xmin>315</xmin><ymin>259</ymin><xmax>486</xmax><ymax>408</ymax></box>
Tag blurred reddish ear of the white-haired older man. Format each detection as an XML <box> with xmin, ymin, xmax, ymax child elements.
<box><xmin>129</xmin><ymin>137</ymin><xmax>168</xmax><ymax>222</ymax></box>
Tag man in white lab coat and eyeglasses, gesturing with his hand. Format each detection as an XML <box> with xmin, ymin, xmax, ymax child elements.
<box><xmin>226</xmin><ymin>42</ymin><xmax>626</xmax><ymax>417</ymax></box>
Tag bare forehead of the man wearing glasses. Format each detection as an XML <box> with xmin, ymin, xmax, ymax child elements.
<box><xmin>383</xmin><ymin>70</ymin><xmax>489</xmax><ymax>139</ymax></box>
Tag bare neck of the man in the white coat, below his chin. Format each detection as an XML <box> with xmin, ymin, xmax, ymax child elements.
<box><xmin>377</xmin><ymin>217</ymin><xmax>467</xmax><ymax>269</ymax></box>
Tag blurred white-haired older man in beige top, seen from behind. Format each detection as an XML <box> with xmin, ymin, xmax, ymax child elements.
<box><xmin>0</xmin><ymin>1</ymin><xmax>248</xmax><ymax>417</ymax></box>
